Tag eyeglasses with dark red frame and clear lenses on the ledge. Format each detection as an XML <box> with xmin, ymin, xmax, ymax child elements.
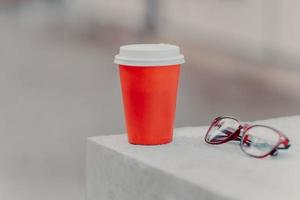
<box><xmin>205</xmin><ymin>116</ymin><xmax>291</xmax><ymax>158</ymax></box>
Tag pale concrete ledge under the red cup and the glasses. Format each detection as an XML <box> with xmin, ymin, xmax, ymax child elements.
<box><xmin>86</xmin><ymin>116</ymin><xmax>300</xmax><ymax>200</ymax></box>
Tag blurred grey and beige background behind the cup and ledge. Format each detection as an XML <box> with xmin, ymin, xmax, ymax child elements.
<box><xmin>0</xmin><ymin>0</ymin><xmax>300</xmax><ymax>200</ymax></box>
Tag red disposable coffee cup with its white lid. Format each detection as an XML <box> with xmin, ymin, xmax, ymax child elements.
<box><xmin>114</xmin><ymin>44</ymin><xmax>185</xmax><ymax>145</ymax></box>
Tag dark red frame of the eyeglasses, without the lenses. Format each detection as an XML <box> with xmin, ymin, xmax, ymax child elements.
<box><xmin>205</xmin><ymin>116</ymin><xmax>291</xmax><ymax>158</ymax></box>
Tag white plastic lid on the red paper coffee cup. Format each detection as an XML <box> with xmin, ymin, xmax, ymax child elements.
<box><xmin>115</xmin><ymin>44</ymin><xmax>185</xmax><ymax>66</ymax></box>
